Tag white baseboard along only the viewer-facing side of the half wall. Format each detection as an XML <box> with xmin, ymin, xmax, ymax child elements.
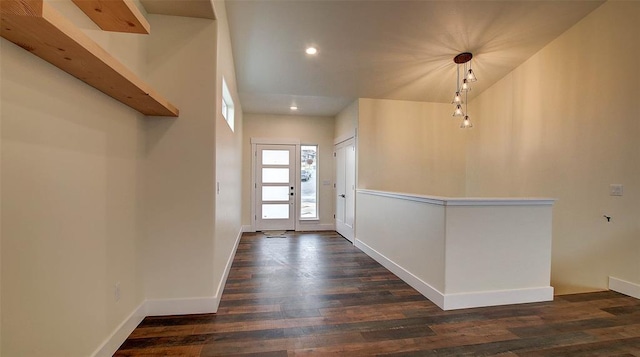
<box><xmin>443</xmin><ymin>286</ymin><xmax>553</xmax><ymax>310</ymax></box>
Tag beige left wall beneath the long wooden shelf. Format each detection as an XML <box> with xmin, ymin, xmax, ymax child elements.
<box><xmin>0</xmin><ymin>32</ymin><xmax>145</xmax><ymax>356</ymax></box>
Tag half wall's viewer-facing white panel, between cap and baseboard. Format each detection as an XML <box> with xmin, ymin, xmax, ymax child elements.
<box><xmin>445</xmin><ymin>204</ymin><xmax>553</xmax><ymax>294</ymax></box>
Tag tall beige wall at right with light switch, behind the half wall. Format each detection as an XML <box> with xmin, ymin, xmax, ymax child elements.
<box><xmin>467</xmin><ymin>1</ymin><xmax>640</xmax><ymax>293</ymax></box>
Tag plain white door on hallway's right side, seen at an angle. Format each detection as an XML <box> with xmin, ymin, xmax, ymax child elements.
<box><xmin>335</xmin><ymin>139</ymin><xmax>356</xmax><ymax>242</ymax></box>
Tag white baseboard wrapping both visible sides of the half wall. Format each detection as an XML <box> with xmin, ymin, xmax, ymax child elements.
<box><xmin>355</xmin><ymin>238</ymin><xmax>553</xmax><ymax>310</ymax></box>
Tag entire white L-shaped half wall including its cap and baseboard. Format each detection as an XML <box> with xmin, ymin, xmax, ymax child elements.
<box><xmin>355</xmin><ymin>190</ymin><xmax>553</xmax><ymax>310</ymax></box>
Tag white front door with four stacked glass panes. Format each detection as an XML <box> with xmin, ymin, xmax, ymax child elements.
<box><xmin>254</xmin><ymin>145</ymin><xmax>297</xmax><ymax>231</ymax></box>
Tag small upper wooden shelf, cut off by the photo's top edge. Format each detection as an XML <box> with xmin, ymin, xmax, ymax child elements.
<box><xmin>72</xmin><ymin>0</ymin><xmax>150</xmax><ymax>34</ymax></box>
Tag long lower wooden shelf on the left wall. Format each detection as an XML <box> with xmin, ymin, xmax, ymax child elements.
<box><xmin>0</xmin><ymin>0</ymin><xmax>179</xmax><ymax>117</ymax></box>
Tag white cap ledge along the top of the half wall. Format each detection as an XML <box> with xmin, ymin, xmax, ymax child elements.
<box><xmin>357</xmin><ymin>189</ymin><xmax>556</xmax><ymax>206</ymax></box>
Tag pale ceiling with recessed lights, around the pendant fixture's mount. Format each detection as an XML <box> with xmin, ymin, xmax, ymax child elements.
<box><xmin>142</xmin><ymin>0</ymin><xmax>603</xmax><ymax>116</ymax></box>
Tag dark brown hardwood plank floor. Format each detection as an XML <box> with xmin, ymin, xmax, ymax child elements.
<box><xmin>115</xmin><ymin>232</ymin><xmax>640</xmax><ymax>357</ymax></box>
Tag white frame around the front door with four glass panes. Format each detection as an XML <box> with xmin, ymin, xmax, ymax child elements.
<box><xmin>250</xmin><ymin>138</ymin><xmax>300</xmax><ymax>232</ymax></box>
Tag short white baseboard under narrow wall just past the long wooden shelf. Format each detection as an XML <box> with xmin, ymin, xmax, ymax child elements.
<box><xmin>145</xmin><ymin>296</ymin><xmax>220</xmax><ymax>316</ymax></box>
